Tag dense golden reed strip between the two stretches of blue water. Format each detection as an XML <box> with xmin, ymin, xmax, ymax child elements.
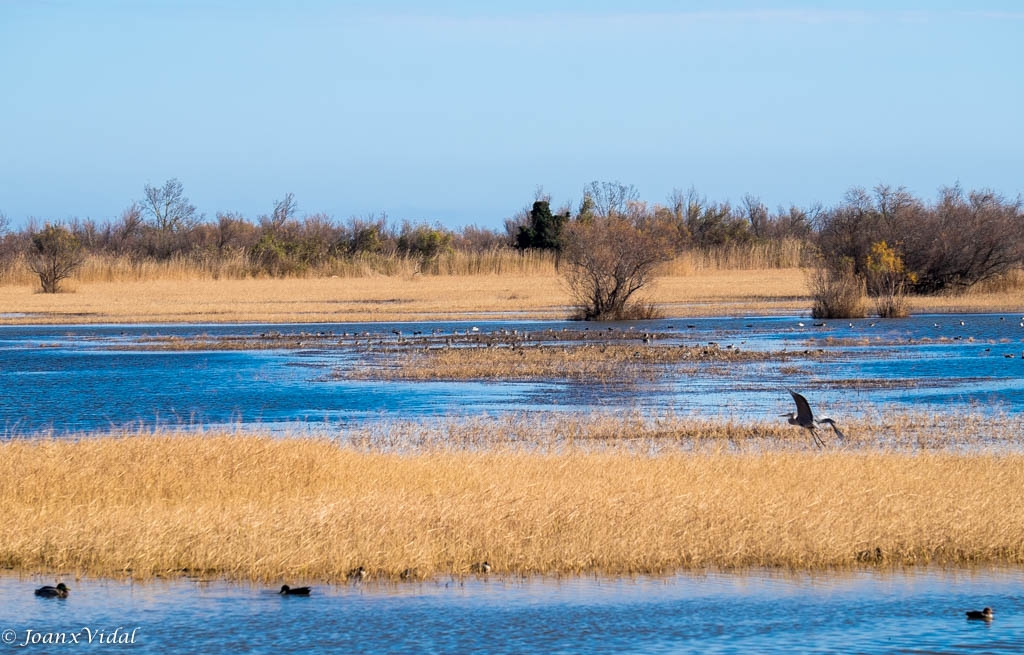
<box><xmin>0</xmin><ymin>418</ymin><xmax>1024</xmax><ymax>582</ymax></box>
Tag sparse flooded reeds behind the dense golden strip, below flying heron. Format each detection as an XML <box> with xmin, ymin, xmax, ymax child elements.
<box><xmin>335</xmin><ymin>411</ymin><xmax>1024</xmax><ymax>454</ymax></box>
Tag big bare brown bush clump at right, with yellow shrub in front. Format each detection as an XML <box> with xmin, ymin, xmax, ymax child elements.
<box><xmin>812</xmin><ymin>185</ymin><xmax>1024</xmax><ymax>317</ymax></box>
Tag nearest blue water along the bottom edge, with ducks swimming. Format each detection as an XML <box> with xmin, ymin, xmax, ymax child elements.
<box><xmin>0</xmin><ymin>571</ymin><xmax>1024</xmax><ymax>653</ymax></box>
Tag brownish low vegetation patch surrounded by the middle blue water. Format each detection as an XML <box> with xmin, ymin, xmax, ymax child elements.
<box><xmin>116</xmin><ymin>329</ymin><xmax>838</xmax><ymax>382</ymax></box>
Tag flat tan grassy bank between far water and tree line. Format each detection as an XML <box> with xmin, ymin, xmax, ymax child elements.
<box><xmin>0</xmin><ymin>268</ymin><xmax>1024</xmax><ymax>323</ymax></box>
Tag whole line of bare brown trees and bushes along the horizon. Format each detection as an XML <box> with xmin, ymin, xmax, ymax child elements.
<box><xmin>0</xmin><ymin>179</ymin><xmax>1024</xmax><ymax>317</ymax></box>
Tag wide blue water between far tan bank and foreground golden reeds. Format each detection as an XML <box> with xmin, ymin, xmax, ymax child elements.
<box><xmin>0</xmin><ymin>314</ymin><xmax>1024</xmax><ymax>435</ymax></box>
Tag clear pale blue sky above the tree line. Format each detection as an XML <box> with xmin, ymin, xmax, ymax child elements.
<box><xmin>0</xmin><ymin>0</ymin><xmax>1024</xmax><ymax>228</ymax></box>
